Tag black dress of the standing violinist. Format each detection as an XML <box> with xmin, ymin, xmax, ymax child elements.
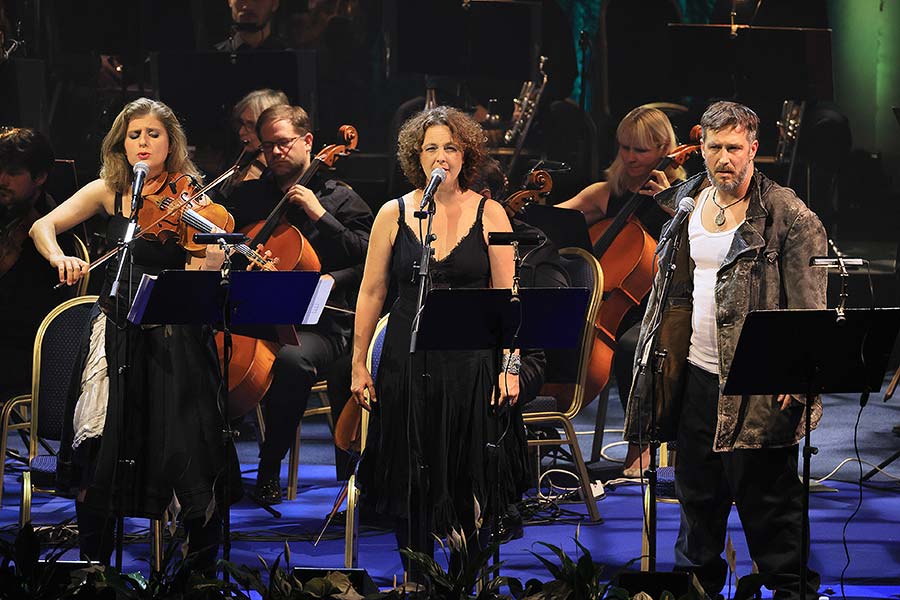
<box><xmin>57</xmin><ymin>194</ymin><xmax>240</xmax><ymax>519</ymax></box>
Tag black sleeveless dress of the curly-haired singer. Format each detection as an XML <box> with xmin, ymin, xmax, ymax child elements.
<box><xmin>359</xmin><ymin>198</ymin><xmax>525</xmax><ymax>535</ymax></box>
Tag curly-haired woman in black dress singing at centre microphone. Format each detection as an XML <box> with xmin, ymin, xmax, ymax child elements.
<box><xmin>351</xmin><ymin>106</ymin><xmax>524</xmax><ymax>583</ymax></box>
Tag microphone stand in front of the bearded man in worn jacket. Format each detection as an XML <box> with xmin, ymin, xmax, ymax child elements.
<box><xmin>628</xmin><ymin>214</ymin><xmax>687</xmax><ymax>572</ymax></box>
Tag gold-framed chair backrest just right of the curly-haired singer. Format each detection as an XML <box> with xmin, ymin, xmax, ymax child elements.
<box><xmin>545</xmin><ymin>248</ymin><xmax>603</xmax><ymax>419</ymax></box>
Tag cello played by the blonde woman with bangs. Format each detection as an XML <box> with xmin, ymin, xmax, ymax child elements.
<box><xmin>561</xmin><ymin>130</ymin><xmax>700</xmax><ymax>410</ymax></box>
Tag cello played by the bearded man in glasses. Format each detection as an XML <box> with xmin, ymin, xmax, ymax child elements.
<box><xmin>216</xmin><ymin>125</ymin><xmax>358</xmax><ymax>418</ymax></box>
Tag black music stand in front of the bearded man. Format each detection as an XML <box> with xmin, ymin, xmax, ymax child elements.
<box><xmin>722</xmin><ymin>308</ymin><xmax>900</xmax><ymax>594</ymax></box>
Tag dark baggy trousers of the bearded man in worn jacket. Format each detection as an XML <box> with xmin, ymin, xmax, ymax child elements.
<box><xmin>675</xmin><ymin>365</ymin><xmax>819</xmax><ymax>599</ymax></box>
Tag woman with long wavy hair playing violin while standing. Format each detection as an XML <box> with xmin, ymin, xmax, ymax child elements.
<box><xmin>30</xmin><ymin>98</ymin><xmax>239</xmax><ymax>568</ymax></box>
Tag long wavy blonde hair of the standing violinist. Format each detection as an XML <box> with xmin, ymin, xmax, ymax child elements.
<box><xmin>100</xmin><ymin>98</ymin><xmax>200</xmax><ymax>192</ymax></box>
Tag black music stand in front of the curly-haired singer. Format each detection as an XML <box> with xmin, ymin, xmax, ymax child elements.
<box><xmin>416</xmin><ymin>288</ymin><xmax>591</xmax><ymax>575</ymax></box>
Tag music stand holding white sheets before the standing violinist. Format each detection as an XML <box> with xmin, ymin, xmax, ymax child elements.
<box><xmin>128</xmin><ymin>267</ymin><xmax>319</xmax><ymax>578</ymax></box>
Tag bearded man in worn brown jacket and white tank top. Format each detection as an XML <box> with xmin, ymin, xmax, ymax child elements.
<box><xmin>626</xmin><ymin>102</ymin><xmax>826</xmax><ymax>598</ymax></box>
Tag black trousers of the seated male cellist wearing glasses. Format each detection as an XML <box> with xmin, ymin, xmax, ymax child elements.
<box><xmin>259</xmin><ymin>331</ymin><xmax>348</xmax><ymax>468</ymax></box>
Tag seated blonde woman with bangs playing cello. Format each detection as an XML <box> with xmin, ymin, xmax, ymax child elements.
<box><xmin>558</xmin><ymin>106</ymin><xmax>684</xmax><ymax>477</ymax></box>
